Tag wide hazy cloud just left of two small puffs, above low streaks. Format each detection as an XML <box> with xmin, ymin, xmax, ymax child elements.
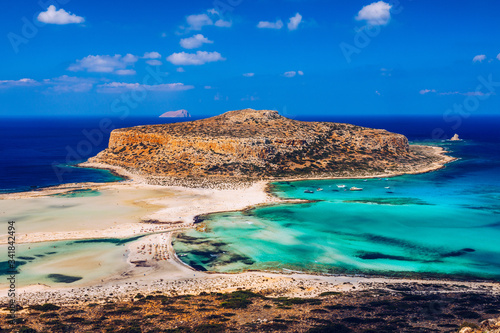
<box><xmin>68</xmin><ymin>54</ymin><xmax>139</xmax><ymax>73</ymax></box>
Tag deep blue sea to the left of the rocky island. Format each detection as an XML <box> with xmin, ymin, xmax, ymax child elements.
<box><xmin>0</xmin><ymin>118</ymin><xmax>188</xmax><ymax>193</ymax></box>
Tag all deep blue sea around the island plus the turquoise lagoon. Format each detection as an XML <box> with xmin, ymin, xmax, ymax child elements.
<box><xmin>0</xmin><ymin>115</ymin><xmax>500</xmax><ymax>280</ymax></box>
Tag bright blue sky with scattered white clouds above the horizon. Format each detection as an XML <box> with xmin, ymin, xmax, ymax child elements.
<box><xmin>0</xmin><ymin>0</ymin><xmax>500</xmax><ymax>117</ymax></box>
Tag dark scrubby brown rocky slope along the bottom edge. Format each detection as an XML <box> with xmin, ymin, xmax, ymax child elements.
<box><xmin>4</xmin><ymin>283</ymin><xmax>500</xmax><ymax>333</ymax></box>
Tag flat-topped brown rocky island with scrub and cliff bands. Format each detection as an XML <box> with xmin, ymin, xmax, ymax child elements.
<box><xmin>89</xmin><ymin>109</ymin><xmax>438</xmax><ymax>183</ymax></box>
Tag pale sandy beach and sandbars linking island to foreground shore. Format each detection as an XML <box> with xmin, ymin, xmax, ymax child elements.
<box><xmin>0</xmin><ymin>141</ymin><xmax>476</xmax><ymax>304</ymax></box>
